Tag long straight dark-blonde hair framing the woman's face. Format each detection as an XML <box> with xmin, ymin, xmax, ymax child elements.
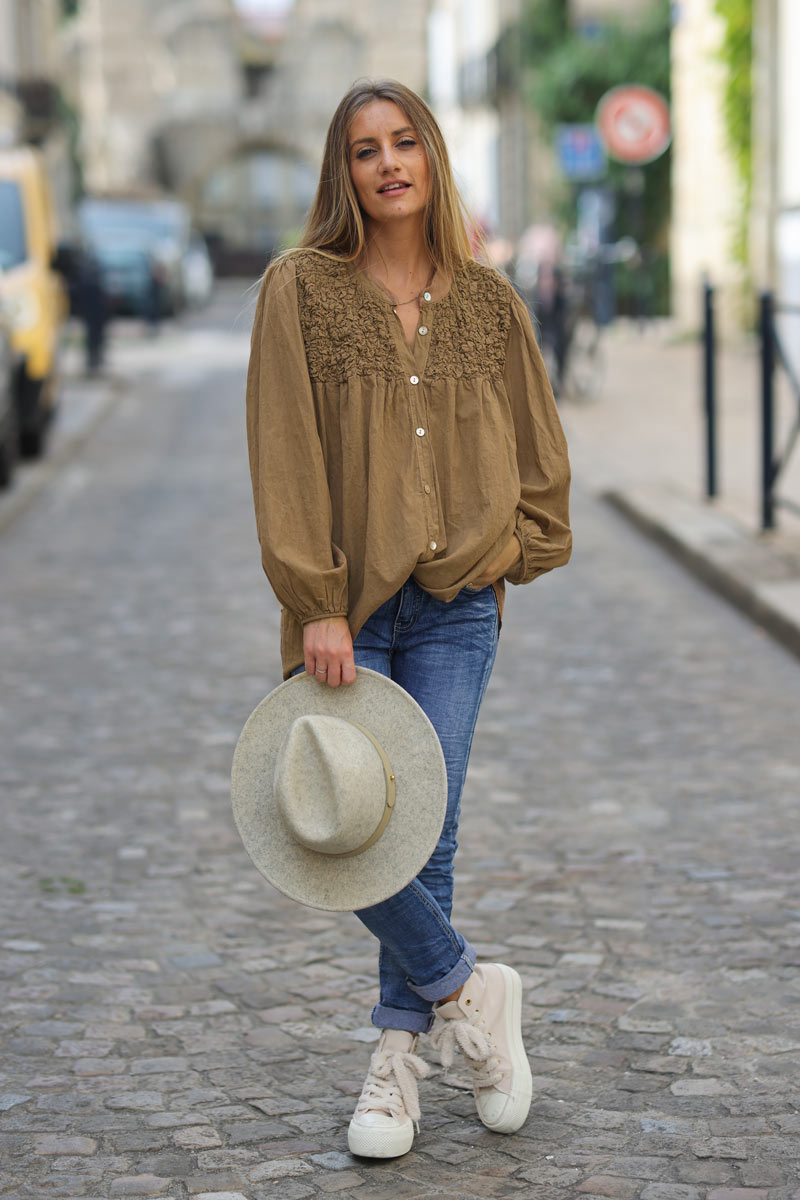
<box><xmin>297</xmin><ymin>79</ymin><xmax>475</xmax><ymax>275</ymax></box>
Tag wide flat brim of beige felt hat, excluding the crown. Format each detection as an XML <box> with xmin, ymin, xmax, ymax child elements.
<box><xmin>230</xmin><ymin>667</ymin><xmax>447</xmax><ymax>912</ymax></box>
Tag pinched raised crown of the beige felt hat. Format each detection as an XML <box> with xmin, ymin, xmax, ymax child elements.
<box><xmin>275</xmin><ymin>714</ymin><xmax>386</xmax><ymax>854</ymax></box>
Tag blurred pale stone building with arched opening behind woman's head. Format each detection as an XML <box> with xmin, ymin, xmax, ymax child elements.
<box><xmin>56</xmin><ymin>0</ymin><xmax>429</xmax><ymax>262</ymax></box>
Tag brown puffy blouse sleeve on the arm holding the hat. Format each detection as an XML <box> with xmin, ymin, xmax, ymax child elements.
<box><xmin>247</xmin><ymin>258</ymin><xmax>348</xmax><ymax>624</ymax></box>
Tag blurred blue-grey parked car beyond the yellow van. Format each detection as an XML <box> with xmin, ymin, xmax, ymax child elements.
<box><xmin>78</xmin><ymin>197</ymin><xmax>190</xmax><ymax>314</ymax></box>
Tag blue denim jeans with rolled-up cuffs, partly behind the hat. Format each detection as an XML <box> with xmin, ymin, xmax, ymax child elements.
<box><xmin>354</xmin><ymin>578</ymin><xmax>499</xmax><ymax>1032</ymax></box>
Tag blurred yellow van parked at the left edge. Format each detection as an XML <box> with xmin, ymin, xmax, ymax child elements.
<box><xmin>0</xmin><ymin>146</ymin><xmax>67</xmax><ymax>456</ymax></box>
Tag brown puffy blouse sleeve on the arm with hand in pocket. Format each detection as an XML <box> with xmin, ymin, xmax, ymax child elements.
<box><xmin>504</xmin><ymin>293</ymin><xmax>572</xmax><ymax>583</ymax></box>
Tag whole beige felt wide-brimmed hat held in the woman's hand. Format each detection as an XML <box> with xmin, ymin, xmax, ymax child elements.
<box><xmin>231</xmin><ymin>667</ymin><xmax>447</xmax><ymax>911</ymax></box>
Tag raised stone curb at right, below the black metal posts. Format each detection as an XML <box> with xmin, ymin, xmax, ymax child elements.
<box><xmin>602</xmin><ymin>490</ymin><xmax>800</xmax><ymax>658</ymax></box>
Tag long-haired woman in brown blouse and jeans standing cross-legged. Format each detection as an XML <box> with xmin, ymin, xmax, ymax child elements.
<box><xmin>247</xmin><ymin>80</ymin><xmax>571</xmax><ymax>1158</ymax></box>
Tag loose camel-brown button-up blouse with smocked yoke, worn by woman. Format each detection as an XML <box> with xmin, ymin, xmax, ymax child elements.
<box><xmin>247</xmin><ymin>251</ymin><xmax>571</xmax><ymax>677</ymax></box>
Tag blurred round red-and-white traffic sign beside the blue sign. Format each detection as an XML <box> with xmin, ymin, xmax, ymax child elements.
<box><xmin>595</xmin><ymin>83</ymin><xmax>672</xmax><ymax>167</ymax></box>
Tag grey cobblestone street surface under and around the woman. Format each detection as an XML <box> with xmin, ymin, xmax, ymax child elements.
<box><xmin>0</xmin><ymin>290</ymin><xmax>800</xmax><ymax>1200</ymax></box>
